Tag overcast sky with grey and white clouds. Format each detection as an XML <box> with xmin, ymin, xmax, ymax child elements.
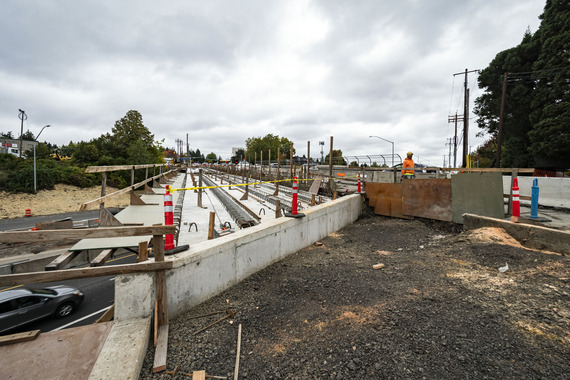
<box><xmin>0</xmin><ymin>0</ymin><xmax>545</xmax><ymax>166</ymax></box>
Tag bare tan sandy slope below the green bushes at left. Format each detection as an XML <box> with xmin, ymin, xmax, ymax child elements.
<box><xmin>0</xmin><ymin>184</ymin><xmax>130</xmax><ymax>219</ymax></box>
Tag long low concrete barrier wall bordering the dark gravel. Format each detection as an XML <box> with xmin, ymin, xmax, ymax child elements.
<box><xmin>115</xmin><ymin>194</ymin><xmax>362</xmax><ymax>321</ymax></box>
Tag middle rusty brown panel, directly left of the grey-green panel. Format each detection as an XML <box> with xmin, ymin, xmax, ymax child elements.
<box><xmin>402</xmin><ymin>179</ymin><xmax>452</xmax><ymax>222</ymax></box>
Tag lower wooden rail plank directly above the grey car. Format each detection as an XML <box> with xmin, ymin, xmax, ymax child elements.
<box><xmin>0</xmin><ymin>261</ymin><xmax>173</xmax><ymax>286</ymax></box>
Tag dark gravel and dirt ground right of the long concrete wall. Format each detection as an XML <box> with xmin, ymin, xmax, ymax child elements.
<box><xmin>141</xmin><ymin>209</ymin><xmax>570</xmax><ymax>379</ymax></box>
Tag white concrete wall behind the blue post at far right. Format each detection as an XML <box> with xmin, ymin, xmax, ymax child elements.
<box><xmin>503</xmin><ymin>175</ymin><xmax>570</xmax><ymax>208</ymax></box>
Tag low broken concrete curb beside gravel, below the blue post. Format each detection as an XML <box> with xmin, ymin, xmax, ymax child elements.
<box><xmin>463</xmin><ymin>214</ymin><xmax>570</xmax><ymax>256</ymax></box>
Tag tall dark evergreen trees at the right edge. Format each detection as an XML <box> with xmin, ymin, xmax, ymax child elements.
<box><xmin>474</xmin><ymin>0</ymin><xmax>570</xmax><ymax>168</ymax></box>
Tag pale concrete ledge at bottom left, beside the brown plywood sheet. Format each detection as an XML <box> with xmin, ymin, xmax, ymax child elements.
<box><xmin>89</xmin><ymin>318</ymin><xmax>151</xmax><ymax>380</ymax></box>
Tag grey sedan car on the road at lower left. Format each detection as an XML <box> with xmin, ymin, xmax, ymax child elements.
<box><xmin>0</xmin><ymin>285</ymin><xmax>83</xmax><ymax>334</ymax></box>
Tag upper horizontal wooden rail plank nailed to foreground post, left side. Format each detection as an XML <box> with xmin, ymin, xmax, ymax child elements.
<box><xmin>0</xmin><ymin>225</ymin><xmax>176</xmax><ymax>243</ymax></box>
